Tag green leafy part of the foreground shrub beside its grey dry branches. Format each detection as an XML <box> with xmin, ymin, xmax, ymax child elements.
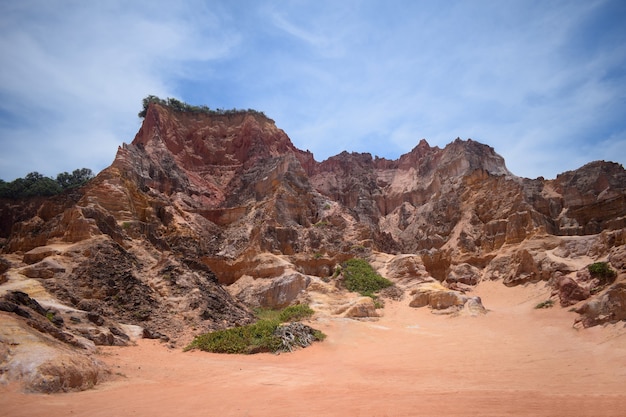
<box><xmin>185</xmin><ymin>304</ymin><xmax>326</xmax><ymax>354</ymax></box>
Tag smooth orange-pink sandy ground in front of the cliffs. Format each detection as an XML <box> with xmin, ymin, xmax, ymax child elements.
<box><xmin>0</xmin><ymin>283</ymin><xmax>626</xmax><ymax>417</ymax></box>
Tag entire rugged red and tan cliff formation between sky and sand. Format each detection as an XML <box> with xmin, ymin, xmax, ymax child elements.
<box><xmin>0</xmin><ymin>104</ymin><xmax>626</xmax><ymax>390</ymax></box>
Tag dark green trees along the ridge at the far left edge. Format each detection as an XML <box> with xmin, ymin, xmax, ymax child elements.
<box><xmin>0</xmin><ymin>168</ymin><xmax>94</xmax><ymax>199</ymax></box>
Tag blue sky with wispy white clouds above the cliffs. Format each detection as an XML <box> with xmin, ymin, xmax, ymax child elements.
<box><xmin>0</xmin><ymin>0</ymin><xmax>626</xmax><ymax>181</ymax></box>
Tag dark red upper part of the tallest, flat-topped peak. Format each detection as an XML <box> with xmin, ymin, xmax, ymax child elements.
<box><xmin>103</xmin><ymin>103</ymin><xmax>322</xmax><ymax>214</ymax></box>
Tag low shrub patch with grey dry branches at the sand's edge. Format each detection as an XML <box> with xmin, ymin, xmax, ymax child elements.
<box><xmin>185</xmin><ymin>304</ymin><xmax>326</xmax><ymax>354</ymax></box>
